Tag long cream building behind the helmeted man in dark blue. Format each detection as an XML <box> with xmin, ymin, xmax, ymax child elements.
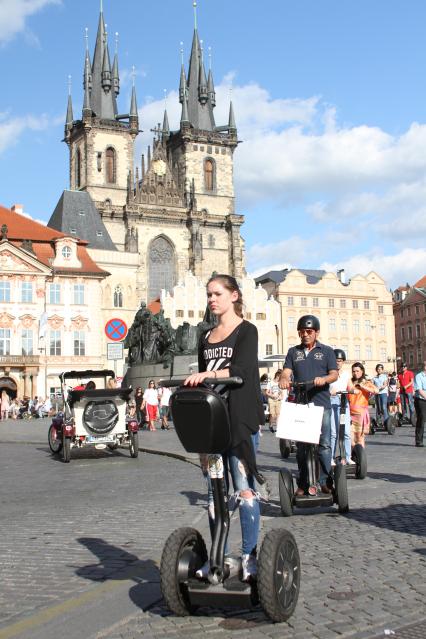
<box><xmin>256</xmin><ymin>269</ymin><xmax>395</xmax><ymax>374</ymax></box>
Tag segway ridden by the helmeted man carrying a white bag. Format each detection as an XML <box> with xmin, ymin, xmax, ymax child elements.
<box><xmin>278</xmin><ymin>381</ymin><xmax>349</xmax><ymax>517</ymax></box>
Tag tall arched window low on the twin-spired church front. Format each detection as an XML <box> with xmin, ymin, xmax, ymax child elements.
<box><xmin>147</xmin><ymin>236</ymin><xmax>176</xmax><ymax>302</ymax></box>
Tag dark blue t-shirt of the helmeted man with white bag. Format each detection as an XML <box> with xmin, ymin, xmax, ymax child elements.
<box><xmin>284</xmin><ymin>342</ymin><xmax>337</xmax><ymax>408</ymax></box>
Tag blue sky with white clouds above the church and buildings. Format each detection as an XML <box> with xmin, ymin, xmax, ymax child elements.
<box><xmin>0</xmin><ymin>0</ymin><xmax>426</xmax><ymax>288</ymax></box>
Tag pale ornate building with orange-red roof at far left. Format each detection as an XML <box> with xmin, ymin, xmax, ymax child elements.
<box><xmin>0</xmin><ymin>206</ymin><xmax>109</xmax><ymax>398</ymax></box>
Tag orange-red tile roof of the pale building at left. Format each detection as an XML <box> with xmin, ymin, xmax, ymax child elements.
<box><xmin>0</xmin><ymin>205</ymin><xmax>108</xmax><ymax>276</ymax></box>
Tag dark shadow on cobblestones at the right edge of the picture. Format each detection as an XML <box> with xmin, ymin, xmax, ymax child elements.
<box><xmin>345</xmin><ymin>504</ymin><xmax>426</xmax><ymax>537</ymax></box>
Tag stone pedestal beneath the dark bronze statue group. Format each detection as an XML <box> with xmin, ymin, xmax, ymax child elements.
<box><xmin>122</xmin><ymin>355</ymin><xmax>198</xmax><ymax>390</ymax></box>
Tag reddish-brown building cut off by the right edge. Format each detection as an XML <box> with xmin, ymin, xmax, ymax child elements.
<box><xmin>393</xmin><ymin>275</ymin><xmax>426</xmax><ymax>370</ymax></box>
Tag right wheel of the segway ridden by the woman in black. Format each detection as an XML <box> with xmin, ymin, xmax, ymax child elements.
<box><xmin>257</xmin><ymin>528</ymin><xmax>300</xmax><ymax>623</ymax></box>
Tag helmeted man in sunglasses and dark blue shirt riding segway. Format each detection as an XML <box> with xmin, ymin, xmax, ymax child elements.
<box><xmin>280</xmin><ymin>315</ymin><xmax>338</xmax><ymax>496</ymax></box>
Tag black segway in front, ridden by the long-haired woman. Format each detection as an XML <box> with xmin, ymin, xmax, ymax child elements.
<box><xmin>160</xmin><ymin>377</ymin><xmax>300</xmax><ymax>622</ymax></box>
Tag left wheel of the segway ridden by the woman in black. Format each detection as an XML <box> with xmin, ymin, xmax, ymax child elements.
<box><xmin>160</xmin><ymin>528</ymin><xmax>207</xmax><ymax>617</ymax></box>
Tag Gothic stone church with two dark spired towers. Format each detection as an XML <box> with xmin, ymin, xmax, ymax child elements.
<box><xmin>49</xmin><ymin>4</ymin><xmax>245</xmax><ymax>310</ymax></box>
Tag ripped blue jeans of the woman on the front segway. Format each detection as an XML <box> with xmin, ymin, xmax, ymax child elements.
<box><xmin>203</xmin><ymin>433</ymin><xmax>260</xmax><ymax>555</ymax></box>
